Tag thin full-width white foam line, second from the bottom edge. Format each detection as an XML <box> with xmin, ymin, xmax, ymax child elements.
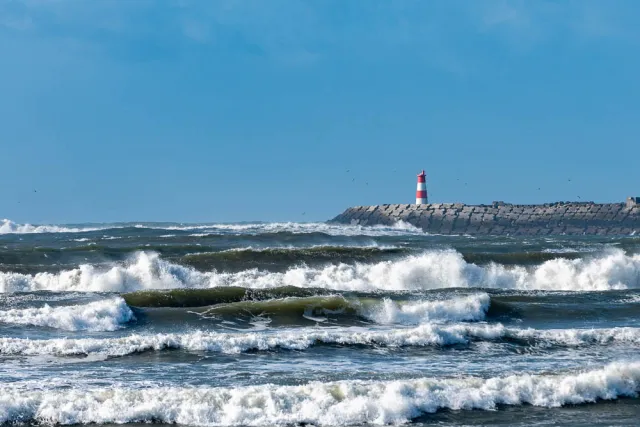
<box><xmin>0</xmin><ymin>323</ymin><xmax>640</xmax><ymax>357</ymax></box>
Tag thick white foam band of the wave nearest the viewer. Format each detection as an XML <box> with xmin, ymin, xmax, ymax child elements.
<box><xmin>0</xmin><ymin>362</ymin><xmax>640</xmax><ymax>426</ymax></box>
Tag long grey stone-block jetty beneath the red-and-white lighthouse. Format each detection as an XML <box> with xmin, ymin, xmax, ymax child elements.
<box><xmin>330</xmin><ymin>197</ymin><xmax>640</xmax><ymax>236</ymax></box>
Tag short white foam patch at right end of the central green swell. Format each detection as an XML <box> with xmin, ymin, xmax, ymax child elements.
<box><xmin>363</xmin><ymin>293</ymin><xmax>491</xmax><ymax>325</ymax></box>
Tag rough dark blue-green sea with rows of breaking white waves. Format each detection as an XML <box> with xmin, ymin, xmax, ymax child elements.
<box><xmin>0</xmin><ymin>220</ymin><xmax>640</xmax><ymax>426</ymax></box>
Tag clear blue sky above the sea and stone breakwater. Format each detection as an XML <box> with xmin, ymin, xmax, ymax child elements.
<box><xmin>0</xmin><ymin>0</ymin><xmax>640</xmax><ymax>223</ymax></box>
